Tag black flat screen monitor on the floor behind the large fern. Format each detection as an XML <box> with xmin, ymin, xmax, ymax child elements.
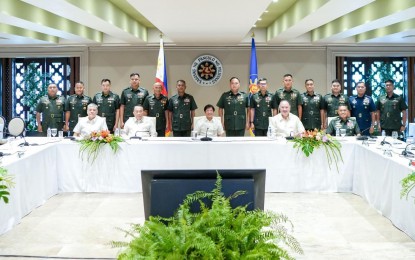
<box><xmin>141</xmin><ymin>169</ymin><xmax>266</xmax><ymax>219</ymax></box>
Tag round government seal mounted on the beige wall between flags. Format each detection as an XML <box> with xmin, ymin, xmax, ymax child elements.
<box><xmin>190</xmin><ymin>54</ymin><xmax>223</xmax><ymax>87</ymax></box>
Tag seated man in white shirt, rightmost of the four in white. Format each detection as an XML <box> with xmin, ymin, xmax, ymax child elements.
<box><xmin>269</xmin><ymin>100</ymin><xmax>305</xmax><ymax>137</ymax></box>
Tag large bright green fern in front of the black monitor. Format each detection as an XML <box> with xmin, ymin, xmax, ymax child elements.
<box><xmin>111</xmin><ymin>175</ymin><xmax>303</xmax><ymax>259</ymax></box>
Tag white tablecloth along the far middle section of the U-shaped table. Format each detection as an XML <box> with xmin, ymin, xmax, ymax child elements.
<box><xmin>56</xmin><ymin>138</ymin><xmax>354</xmax><ymax>192</ymax></box>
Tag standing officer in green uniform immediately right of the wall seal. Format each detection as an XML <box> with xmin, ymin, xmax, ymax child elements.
<box><xmin>216</xmin><ymin>77</ymin><xmax>250</xmax><ymax>136</ymax></box>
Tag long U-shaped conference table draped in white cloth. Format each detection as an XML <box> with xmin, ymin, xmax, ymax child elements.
<box><xmin>0</xmin><ymin>137</ymin><xmax>415</xmax><ymax>239</ymax></box>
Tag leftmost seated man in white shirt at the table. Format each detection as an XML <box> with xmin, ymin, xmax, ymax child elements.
<box><xmin>73</xmin><ymin>103</ymin><xmax>108</xmax><ymax>137</ymax></box>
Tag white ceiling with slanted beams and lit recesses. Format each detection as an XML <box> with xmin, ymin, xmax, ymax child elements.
<box><xmin>0</xmin><ymin>0</ymin><xmax>415</xmax><ymax>46</ymax></box>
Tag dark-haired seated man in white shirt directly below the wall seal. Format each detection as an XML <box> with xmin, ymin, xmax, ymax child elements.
<box><xmin>195</xmin><ymin>104</ymin><xmax>224</xmax><ymax>137</ymax></box>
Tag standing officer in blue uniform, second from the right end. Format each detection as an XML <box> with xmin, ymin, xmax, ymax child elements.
<box><xmin>349</xmin><ymin>81</ymin><xmax>377</xmax><ymax>135</ymax></box>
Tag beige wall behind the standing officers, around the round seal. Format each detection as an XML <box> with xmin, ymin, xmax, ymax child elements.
<box><xmin>88</xmin><ymin>47</ymin><xmax>330</xmax><ymax>115</ymax></box>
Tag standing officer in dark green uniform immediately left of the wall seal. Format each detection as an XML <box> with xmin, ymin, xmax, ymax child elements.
<box><xmin>167</xmin><ymin>79</ymin><xmax>197</xmax><ymax>136</ymax></box>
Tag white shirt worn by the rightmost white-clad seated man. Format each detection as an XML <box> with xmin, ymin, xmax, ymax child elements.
<box><xmin>269</xmin><ymin>113</ymin><xmax>305</xmax><ymax>137</ymax></box>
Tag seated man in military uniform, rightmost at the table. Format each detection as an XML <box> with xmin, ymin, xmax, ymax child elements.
<box><xmin>326</xmin><ymin>105</ymin><xmax>360</xmax><ymax>136</ymax></box>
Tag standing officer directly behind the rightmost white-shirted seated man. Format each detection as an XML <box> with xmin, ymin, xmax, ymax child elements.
<box><xmin>272</xmin><ymin>74</ymin><xmax>303</xmax><ymax>120</ymax></box>
